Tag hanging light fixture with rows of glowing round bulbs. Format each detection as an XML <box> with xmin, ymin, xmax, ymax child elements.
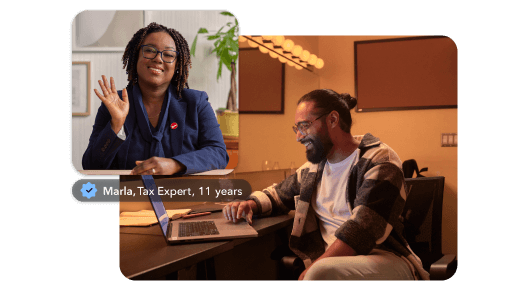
<box><xmin>239</xmin><ymin>35</ymin><xmax>324</xmax><ymax>72</ymax></box>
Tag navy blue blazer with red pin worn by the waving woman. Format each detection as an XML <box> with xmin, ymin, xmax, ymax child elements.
<box><xmin>82</xmin><ymin>85</ymin><xmax>229</xmax><ymax>174</ymax></box>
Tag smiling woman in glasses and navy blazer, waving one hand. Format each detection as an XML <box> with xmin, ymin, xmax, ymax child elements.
<box><xmin>83</xmin><ymin>23</ymin><xmax>228</xmax><ymax>175</ymax></box>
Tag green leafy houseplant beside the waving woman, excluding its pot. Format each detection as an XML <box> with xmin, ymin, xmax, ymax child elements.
<box><xmin>190</xmin><ymin>11</ymin><xmax>239</xmax><ymax>111</ymax></box>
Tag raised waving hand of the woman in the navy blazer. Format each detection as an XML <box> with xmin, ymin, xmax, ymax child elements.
<box><xmin>94</xmin><ymin>76</ymin><xmax>129</xmax><ymax>134</ymax></box>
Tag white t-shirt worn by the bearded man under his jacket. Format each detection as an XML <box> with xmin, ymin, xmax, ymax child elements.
<box><xmin>311</xmin><ymin>149</ymin><xmax>359</xmax><ymax>250</ymax></box>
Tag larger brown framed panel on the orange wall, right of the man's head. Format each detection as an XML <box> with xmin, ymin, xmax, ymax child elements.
<box><xmin>354</xmin><ymin>36</ymin><xmax>458</xmax><ymax>112</ymax></box>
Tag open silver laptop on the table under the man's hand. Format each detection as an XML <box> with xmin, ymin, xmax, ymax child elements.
<box><xmin>142</xmin><ymin>175</ymin><xmax>258</xmax><ymax>244</ymax></box>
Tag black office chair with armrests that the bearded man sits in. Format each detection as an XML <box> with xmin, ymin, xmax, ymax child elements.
<box><xmin>271</xmin><ymin>176</ymin><xmax>458</xmax><ymax>281</ymax></box>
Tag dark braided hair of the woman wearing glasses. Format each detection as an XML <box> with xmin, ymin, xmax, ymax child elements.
<box><xmin>122</xmin><ymin>22</ymin><xmax>191</xmax><ymax>96</ymax></box>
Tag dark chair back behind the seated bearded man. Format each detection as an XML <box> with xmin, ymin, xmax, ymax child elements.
<box><xmin>402</xmin><ymin>176</ymin><xmax>445</xmax><ymax>271</ymax></box>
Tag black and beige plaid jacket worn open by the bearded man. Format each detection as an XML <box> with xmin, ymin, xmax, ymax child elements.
<box><xmin>249</xmin><ymin>133</ymin><xmax>429</xmax><ymax>280</ymax></box>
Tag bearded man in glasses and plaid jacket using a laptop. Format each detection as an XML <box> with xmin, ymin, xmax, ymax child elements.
<box><xmin>223</xmin><ymin>89</ymin><xmax>429</xmax><ymax>280</ymax></box>
